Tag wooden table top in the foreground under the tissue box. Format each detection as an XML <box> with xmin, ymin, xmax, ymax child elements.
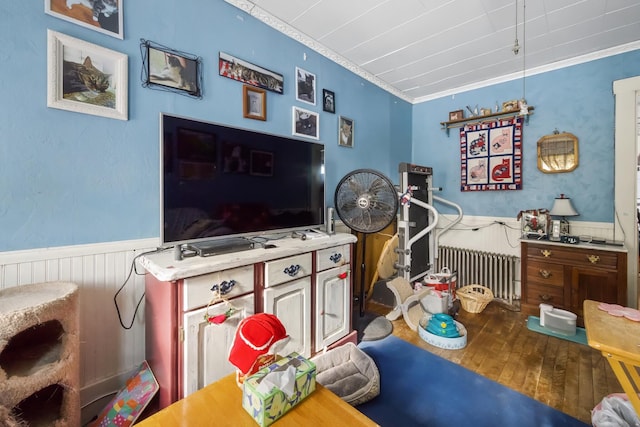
<box><xmin>136</xmin><ymin>374</ymin><xmax>377</xmax><ymax>427</ymax></box>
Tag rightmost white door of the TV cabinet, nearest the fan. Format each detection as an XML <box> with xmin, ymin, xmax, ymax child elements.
<box><xmin>314</xmin><ymin>265</ymin><xmax>351</xmax><ymax>351</ymax></box>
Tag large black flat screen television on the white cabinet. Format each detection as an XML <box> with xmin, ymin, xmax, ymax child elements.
<box><xmin>160</xmin><ymin>113</ymin><xmax>325</xmax><ymax>247</ymax></box>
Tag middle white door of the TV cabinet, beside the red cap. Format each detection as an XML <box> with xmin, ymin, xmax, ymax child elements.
<box><xmin>264</xmin><ymin>277</ymin><xmax>311</xmax><ymax>357</ymax></box>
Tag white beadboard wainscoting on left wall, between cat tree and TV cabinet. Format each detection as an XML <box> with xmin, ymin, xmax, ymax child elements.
<box><xmin>0</xmin><ymin>239</ymin><xmax>158</xmax><ymax>405</ymax></box>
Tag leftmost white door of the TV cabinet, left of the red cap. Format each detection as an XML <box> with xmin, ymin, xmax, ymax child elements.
<box><xmin>180</xmin><ymin>294</ymin><xmax>254</xmax><ymax>398</ymax></box>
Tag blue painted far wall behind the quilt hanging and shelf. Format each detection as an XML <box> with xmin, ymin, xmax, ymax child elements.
<box><xmin>413</xmin><ymin>51</ymin><xmax>640</xmax><ymax>222</ymax></box>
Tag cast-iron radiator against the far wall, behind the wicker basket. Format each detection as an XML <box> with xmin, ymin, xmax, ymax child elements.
<box><xmin>436</xmin><ymin>246</ymin><xmax>518</xmax><ymax>305</ymax></box>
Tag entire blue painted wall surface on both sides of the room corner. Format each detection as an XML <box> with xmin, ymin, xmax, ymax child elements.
<box><xmin>0</xmin><ymin>0</ymin><xmax>640</xmax><ymax>251</ymax></box>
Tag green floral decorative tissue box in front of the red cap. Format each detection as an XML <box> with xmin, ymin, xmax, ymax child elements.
<box><xmin>242</xmin><ymin>353</ymin><xmax>316</xmax><ymax>427</ymax></box>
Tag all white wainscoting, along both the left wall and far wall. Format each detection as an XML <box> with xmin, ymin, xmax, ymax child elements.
<box><xmin>0</xmin><ymin>215</ymin><xmax>613</xmax><ymax>412</ymax></box>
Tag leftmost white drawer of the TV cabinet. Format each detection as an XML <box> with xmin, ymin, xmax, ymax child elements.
<box><xmin>182</xmin><ymin>264</ymin><xmax>253</xmax><ymax>311</ymax></box>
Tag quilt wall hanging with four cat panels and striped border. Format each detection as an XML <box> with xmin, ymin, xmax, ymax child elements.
<box><xmin>460</xmin><ymin>117</ymin><xmax>522</xmax><ymax>191</ymax></box>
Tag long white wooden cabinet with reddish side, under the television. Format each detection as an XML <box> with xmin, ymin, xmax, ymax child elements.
<box><xmin>139</xmin><ymin>233</ymin><xmax>356</xmax><ymax>409</ymax></box>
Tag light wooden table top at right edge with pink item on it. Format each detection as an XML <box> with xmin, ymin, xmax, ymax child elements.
<box><xmin>584</xmin><ymin>300</ymin><xmax>640</xmax><ymax>365</ymax></box>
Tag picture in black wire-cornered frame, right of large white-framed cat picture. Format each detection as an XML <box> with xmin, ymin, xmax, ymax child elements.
<box><xmin>140</xmin><ymin>40</ymin><xmax>202</xmax><ymax>98</ymax></box>
